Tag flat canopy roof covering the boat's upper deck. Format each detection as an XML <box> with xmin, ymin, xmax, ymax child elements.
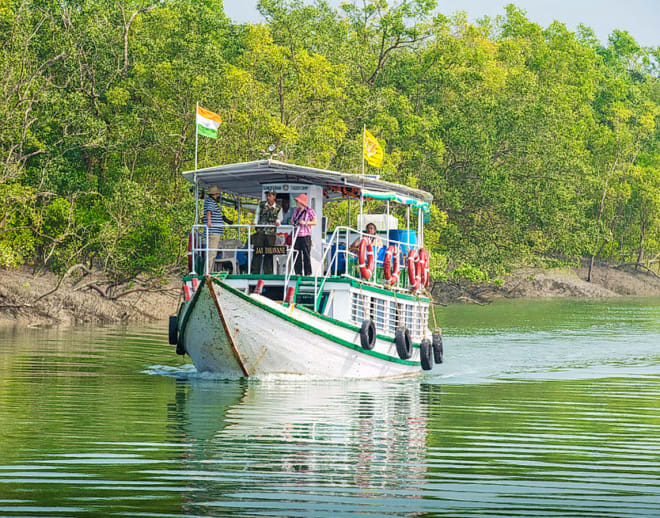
<box><xmin>183</xmin><ymin>160</ymin><xmax>433</xmax><ymax>211</ymax></box>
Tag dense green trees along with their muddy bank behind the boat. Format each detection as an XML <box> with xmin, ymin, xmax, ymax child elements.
<box><xmin>0</xmin><ymin>0</ymin><xmax>660</xmax><ymax>330</ymax></box>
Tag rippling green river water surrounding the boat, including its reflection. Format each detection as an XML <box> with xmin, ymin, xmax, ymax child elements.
<box><xmin>0</xmin><ymin>299</ymin><xmax>660</xmax><ymax>517</ymax></box>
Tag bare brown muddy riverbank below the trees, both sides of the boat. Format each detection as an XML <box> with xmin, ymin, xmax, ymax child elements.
<box><xmin>0</xmin><ymin>266</ymin><xmax>660</xmax><ymax>326</ymax></box>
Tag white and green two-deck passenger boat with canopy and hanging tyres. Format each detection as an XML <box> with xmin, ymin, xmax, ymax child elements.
<box><xmin>169</xmin><ymin>159</ymin><xmax>443</xmax><ymax>379</ymax></box>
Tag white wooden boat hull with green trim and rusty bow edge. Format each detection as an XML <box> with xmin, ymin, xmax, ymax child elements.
<box><xmin>178</xmin><ymin>277</ymin><xmax>421</xmax><ymax>378</ymax></box>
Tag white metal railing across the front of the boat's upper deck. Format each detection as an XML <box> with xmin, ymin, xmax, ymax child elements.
<box><xmin>188</xmin><ymin>223</ymin><xmax>297</xmax><ymax>275</ymax></box>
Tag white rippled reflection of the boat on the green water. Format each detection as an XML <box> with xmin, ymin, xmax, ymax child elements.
<box><xmin>171</xmin><ymin>381</ymin><xmax>439</xmax><ymax>505</ymax></box>
